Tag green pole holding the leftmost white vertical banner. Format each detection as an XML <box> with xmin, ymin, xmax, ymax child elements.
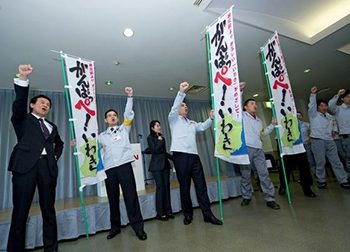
<box><xmin>61</xmin><ymin>55</ymin><xmax>89</xmax><ymax>238</ymax></box>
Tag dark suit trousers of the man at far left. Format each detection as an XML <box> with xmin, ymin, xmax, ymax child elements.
<box><xmin>7</xmin><ymin>158</ymin><xmax>58</xmax><ymax>252</ymax></box>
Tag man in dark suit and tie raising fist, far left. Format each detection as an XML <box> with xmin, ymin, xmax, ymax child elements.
<box><xmin>7</xmin><ymin>65</ymin><xmax>63</xmax><ymax>252</ymax></box>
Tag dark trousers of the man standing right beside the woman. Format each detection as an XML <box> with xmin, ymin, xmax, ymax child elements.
<box><xmin>173</xmin><ymin>152</ymin><xmax>212</xmax><ymax>217</ymax></box>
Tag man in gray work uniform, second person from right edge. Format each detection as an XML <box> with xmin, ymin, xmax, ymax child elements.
<box><xmin>308</xmin><ymin>86</ymin><xmax>350</xmax><ymax>189</ymax></box>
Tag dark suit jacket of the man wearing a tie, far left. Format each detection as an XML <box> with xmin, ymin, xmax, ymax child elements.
<box><xmin>8</xmin><ymin>85</ymin><xmax>63</xmax><ymax>176</ymax></box>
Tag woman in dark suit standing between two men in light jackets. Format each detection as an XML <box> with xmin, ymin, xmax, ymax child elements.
<box><xmin>147</xmin><ymin>120</ymin><xmax>174</xmax><ymax>220</ymax></box>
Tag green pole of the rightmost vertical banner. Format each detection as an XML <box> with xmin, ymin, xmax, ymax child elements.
<box><xmin>260</xmin><ymin>47</ymin><xmax>292</xmax><ymax>204</ymax></box>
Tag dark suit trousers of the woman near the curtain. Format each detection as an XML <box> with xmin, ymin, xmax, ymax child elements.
<box><xmin>152</xmin><ymin>168</ymin><xmax>172</xmax><ymax>216</ymax></box>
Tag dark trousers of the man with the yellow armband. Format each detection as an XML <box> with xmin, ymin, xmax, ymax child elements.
<box><xmin>105</xmin><ymin>163</ymin><xmax>143</xmax><ymax>233</ymax></box>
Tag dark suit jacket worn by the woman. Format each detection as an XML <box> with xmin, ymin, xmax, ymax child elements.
<box><xmin>147</xmin><ymin>135</ymin><xmax>172</xmax><ymax>171</ymax></box>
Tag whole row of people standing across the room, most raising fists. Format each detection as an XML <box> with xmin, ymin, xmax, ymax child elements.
<box><xmin>7</xmin><ymin>65</ymin><xmax>350</xmax><ymax>252</ymax></box>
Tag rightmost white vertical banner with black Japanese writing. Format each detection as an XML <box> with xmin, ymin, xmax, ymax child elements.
<box><xmin>260</xmin><ymin>32</ymin><xmax>305</xmax><ymax>155</ymax></box>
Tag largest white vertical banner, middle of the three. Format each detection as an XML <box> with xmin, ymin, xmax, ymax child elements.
<box><xmin>206</xmin><ymin>7</ymin><xmax>249</xmax><ymax>164</ymax></box>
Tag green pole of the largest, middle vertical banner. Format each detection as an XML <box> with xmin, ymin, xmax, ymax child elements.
<box><xmin>205</xmin><ymin>32</ymin><xmax>224</xmax><ymax>220</ymax></box>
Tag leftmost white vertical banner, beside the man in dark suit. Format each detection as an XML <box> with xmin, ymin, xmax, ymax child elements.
<box><xmin>62</xmin><ymin>55</ymin><xmax>106</xmax><ymax>187</ymax></box>
